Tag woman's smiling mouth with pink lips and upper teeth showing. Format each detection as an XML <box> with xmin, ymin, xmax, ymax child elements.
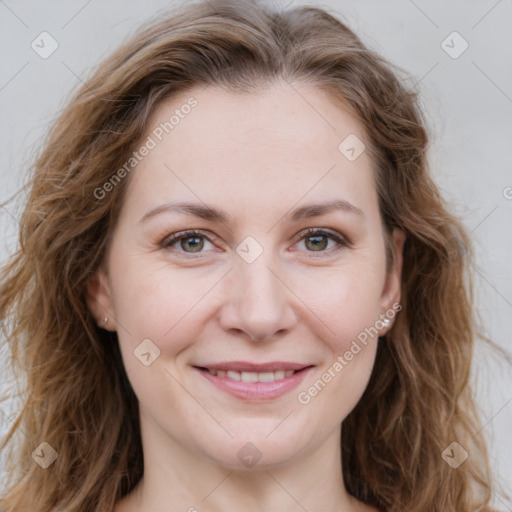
<box><xmin>194</xmin><ymin>362</ymin><xmax>313</xmax><ymax>401</ymax></box>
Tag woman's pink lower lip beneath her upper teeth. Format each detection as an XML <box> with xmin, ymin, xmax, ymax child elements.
<box><xmin>196</xmin><ymin>366</ymin><xmax>312</xmax><ymax>401</ymax></box>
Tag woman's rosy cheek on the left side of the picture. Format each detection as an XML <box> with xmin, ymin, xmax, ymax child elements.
<box><xmin>108</xmin><ymin>258</ymin><xmax>214</xmax><ymax>410</ymax></box>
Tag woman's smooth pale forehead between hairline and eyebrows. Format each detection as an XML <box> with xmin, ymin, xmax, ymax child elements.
<box><xmin>122</xmin><ymin>81</ymin><xmax>374</xmax><ymax>221</ymax></box>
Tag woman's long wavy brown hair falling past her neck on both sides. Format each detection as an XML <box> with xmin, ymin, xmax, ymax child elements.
<box><xmin>0</xmin><ymin>0</ymin><xmax>504</xmax><ymax>512</ymax></box>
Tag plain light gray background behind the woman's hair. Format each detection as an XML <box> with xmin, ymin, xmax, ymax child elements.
<box><xmin>0</xmin><ymin>0</ymin><xmax>512</xmax><ymax>511</ymax></box>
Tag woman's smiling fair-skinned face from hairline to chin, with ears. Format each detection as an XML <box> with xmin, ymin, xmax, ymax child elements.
<box><xmin>89</xmin><ymin>82</ymin><xmax>404</xmax><ymax>468</ymax></box>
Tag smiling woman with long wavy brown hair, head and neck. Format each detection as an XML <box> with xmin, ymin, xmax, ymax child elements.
<box><xmin>0</xmin><ymin>0</ymin><xmax>504</xmax><ymax>512</ymax></box>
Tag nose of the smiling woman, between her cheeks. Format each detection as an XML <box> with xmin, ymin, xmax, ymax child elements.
<box><xmin>219</xmin><ymin>251</ymin><xmax>296</xmax><ymax>341</ymax></box>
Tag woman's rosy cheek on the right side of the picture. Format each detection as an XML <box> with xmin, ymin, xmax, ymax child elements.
<box><xmin>297</xmin><ymin>273</ymin><xmax>380</xmax><ymax>416</ymax></box>
